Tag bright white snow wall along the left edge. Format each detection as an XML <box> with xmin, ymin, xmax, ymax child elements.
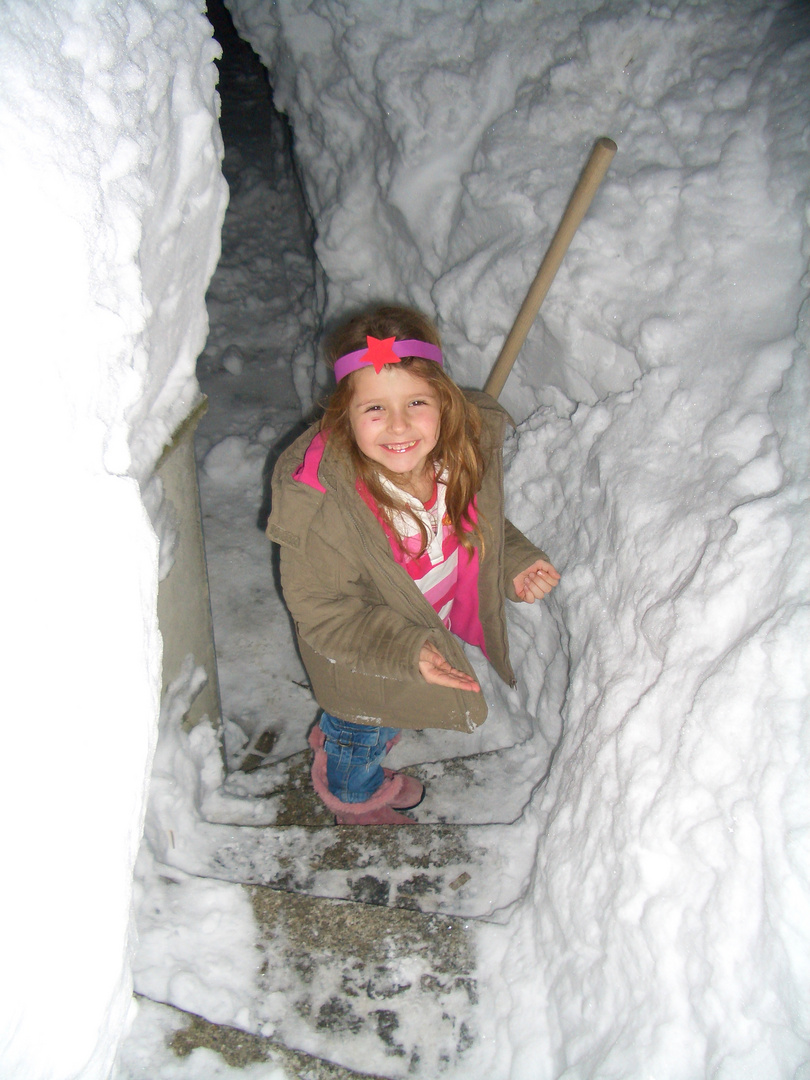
<box><xmin>0</xmin><ymin>0</ymin><xmax>226</xmax><ymax>1080</ymax></box>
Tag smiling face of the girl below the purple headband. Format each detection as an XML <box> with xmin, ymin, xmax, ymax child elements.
<box><xmin>349</xmin><ymin>364</ymin><xmax>441</xmax><ymax>487</ymax></box>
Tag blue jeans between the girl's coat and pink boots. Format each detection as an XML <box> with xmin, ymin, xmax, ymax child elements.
<box><xmin>320</xmin><ymin>713</ymin><xmax>400</xmax><ymax>802</ymax></box>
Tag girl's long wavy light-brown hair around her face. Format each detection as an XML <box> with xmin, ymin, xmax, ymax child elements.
<box><xmin>321</xmin><ymin>305</ymin><xmax>484</xmax><ymax>553</ymax></box>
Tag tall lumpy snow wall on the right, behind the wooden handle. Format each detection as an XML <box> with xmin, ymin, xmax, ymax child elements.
<box><xmin>229</xmin><ymin>0</ymin><xmax>810</xmax><ymax>1080</ymax></box>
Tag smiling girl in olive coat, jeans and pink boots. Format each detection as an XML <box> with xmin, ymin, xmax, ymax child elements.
<box><xmin>268</xmin><ymin>307</ymin><xmax>559</xmax><ymax>824</ymax></box>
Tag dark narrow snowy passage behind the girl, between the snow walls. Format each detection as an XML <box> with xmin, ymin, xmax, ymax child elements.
<box><xmin>195</xmin><ymin>0</ymin><xmax>323</xmax><ymax>766</ymax></box>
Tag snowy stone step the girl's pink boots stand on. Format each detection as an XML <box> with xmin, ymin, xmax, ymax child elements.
<box><xmin>216</xmin><ymin>744</ymin><xmax>543</xmax><ymax>825</ymax></box>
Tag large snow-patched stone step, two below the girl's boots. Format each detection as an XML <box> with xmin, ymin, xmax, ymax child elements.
<box><xmin>131</xmin><ymin>885</ymin><xmax>480</xmax><ymax>1080</ymax></box>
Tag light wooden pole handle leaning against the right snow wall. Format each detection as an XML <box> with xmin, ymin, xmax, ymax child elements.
<box><xmin>484</xmin><ymin>136</ymin><xmax>616</xmax><ymax>397</ymax></box>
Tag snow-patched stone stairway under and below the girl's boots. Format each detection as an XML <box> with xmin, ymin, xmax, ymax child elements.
<box><xmin>120</xmin><ymin>746</ymin><xmax>548</xmax><ymax>1080</ymax></box>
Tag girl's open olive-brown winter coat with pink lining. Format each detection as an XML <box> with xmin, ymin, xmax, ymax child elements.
<box><xmin>267</xmin><ymin>393</ymin><xmax>548</xmax><ymax>731</ymax></box>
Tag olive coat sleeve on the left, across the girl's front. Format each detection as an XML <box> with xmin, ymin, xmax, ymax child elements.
<box><xmin>281</xmin><ymin>522</ymin><xmax>431</xmax><ymax>680</ymax></box>
